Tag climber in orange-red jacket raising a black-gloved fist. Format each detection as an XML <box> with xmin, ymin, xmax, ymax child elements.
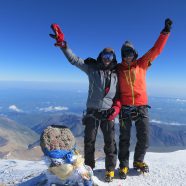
<box><xmin>117</xmin><ymin>19</ymin><xmax>172</xmax><ymax>179</ymax></box>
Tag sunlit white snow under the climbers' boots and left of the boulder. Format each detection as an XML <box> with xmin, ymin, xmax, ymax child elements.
<box><xmin>0</xmin><ymin>150</ymin><xmax>186</xmax><ymax>186</ymax></box>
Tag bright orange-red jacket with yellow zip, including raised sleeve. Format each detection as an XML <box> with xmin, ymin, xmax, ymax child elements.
<box><xmin>117</xmin><ymin>34</ymin><xmax>169</xmax><ymax>106</ymax></box>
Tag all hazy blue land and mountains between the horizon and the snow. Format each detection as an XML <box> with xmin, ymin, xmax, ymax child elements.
<box><xmin>0</xmin><ymin>88</ymin><xmax>186</xmax><ymax>159</ymax></box>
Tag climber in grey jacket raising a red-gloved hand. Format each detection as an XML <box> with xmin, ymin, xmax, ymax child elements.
<box><xmin>50</xmin><ymin>24</ymin><xmax>121</xmax><ymax>182</ymax></box>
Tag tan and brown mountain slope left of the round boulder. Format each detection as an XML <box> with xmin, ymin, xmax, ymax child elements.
<box><xmin>0</xmin><ymin>116</ymin><xmax>39</xmax><ymax>159</ymax></box>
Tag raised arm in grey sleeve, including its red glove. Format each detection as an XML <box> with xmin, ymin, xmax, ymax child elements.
<box><xmin>50</xmin><ymin>24</ymin><xmax>88</xmax><ymax>73</ymax></box>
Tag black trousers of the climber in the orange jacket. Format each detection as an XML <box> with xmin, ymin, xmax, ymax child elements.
<box><xmin>118</xmin><ymin>106</ymin><xmax>149</xmax><ymax>168</ymax></box>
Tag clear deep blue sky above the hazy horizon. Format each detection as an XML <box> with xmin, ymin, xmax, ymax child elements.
<box><xmin>0</xmin><ymin>0</ymin><xmax>186</xmax><ymax>96</ymax></box>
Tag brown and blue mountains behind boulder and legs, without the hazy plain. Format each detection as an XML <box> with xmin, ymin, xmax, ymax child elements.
<box><xmin>0</xmin><ymin>113</ymin><xmax>186</xmax><ymax>159</ymax></box>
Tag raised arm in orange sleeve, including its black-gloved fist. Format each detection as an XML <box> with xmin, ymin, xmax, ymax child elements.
<box><xmin>138</xmin><ymin>19</ymin><xmax>172</xmax><ymax>68</ymax></box>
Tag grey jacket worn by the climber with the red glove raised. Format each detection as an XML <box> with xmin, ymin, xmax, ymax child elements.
<box><xmin>61</xmin><ymin>47</ymin><xmax>118</xmax><ymax>110</ymax></box>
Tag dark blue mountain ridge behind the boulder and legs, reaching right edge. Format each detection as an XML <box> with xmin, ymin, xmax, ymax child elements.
<box><xmin>32</xmin><ymin>114</ymin><xmax>186</xmax><ymax>150</ymax></box>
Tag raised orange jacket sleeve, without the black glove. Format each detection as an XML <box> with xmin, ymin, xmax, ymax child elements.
<box><xmin>137</xmin><ymin>33</ymin><xmax>169</xmax><ymax>69</ymax></box>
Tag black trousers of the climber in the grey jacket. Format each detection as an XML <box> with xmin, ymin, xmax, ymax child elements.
<box><xmin>83</xmin><ymin>112</ymin><xmax>117</xmax><ymax>171</ymax></box>
